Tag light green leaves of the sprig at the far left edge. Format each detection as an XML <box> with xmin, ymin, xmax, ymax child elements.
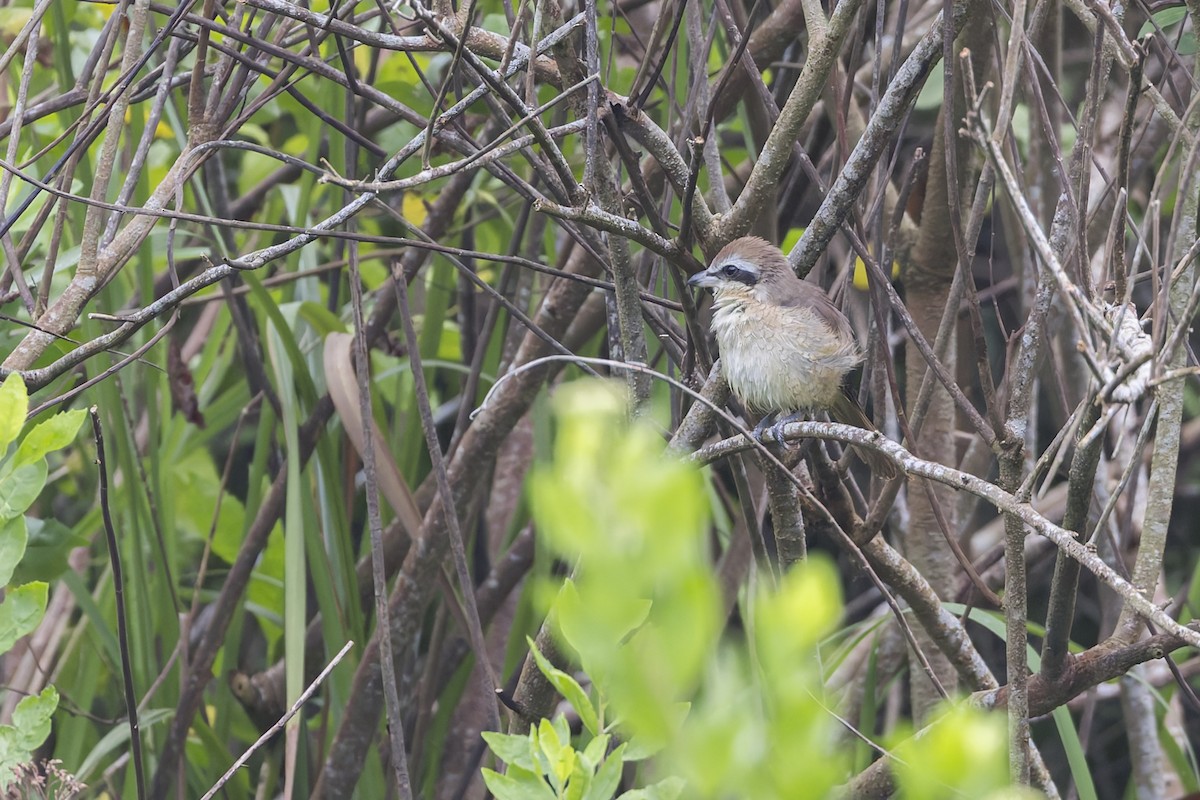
<box><xmin>0</xmin><ymin>375</ymin><xmax>85</xmax><ymax>789</ymax></box>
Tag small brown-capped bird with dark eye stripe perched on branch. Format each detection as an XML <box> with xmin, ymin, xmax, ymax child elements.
<box><xmin>688</xmin><ymin>236</ymin><xmax>895</xmax><ymax>479</ymax></box>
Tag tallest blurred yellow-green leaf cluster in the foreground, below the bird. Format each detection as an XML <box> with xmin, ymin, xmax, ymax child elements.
<box><xmin>530</xmin><ymin>381</ymin><xmax>721</xmax><ymax>740</ymax></box>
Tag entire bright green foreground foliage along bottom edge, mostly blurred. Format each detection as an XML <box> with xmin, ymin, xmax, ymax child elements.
<box><xmin>484</xmin><ymin>381</ymin><xmax>1032</xmax><ymax>800</ymax></box>
